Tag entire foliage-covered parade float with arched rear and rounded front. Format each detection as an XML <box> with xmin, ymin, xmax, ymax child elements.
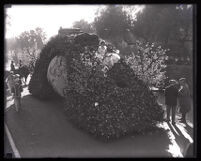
<box><xmin>29</xmin><ymin>29</ymin><xmax>163</xmax><ymax>140</ymax></box>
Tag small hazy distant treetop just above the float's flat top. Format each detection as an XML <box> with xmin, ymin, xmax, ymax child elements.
<box><xmin>73</xmin><ymin>19</ymin><xmax>94</xmax><ymax>33</ymax></box>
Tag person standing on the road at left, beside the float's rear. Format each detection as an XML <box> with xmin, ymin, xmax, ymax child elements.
<box><xmin>11</xmin><ymin>74</ymin><xmax>23</xmax><ymax>112</ymax></box>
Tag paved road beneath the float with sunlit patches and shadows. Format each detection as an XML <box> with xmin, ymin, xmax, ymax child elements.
<box><xmin>5</xmin><ymin>88</ymin><xmax>192</xmax><ymax>158</ymax></box>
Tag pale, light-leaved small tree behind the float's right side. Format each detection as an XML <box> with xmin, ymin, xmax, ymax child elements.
<box><xmin>125</xmin><ymin>41</ymin><xmax>168</xmax><ymax>87</ymax></box>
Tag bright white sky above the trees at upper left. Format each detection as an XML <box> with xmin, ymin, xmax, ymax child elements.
<box><xmin>5</xmin><ymin>5</ymin><xmax>144</xmax><ymax>39</ymax></box>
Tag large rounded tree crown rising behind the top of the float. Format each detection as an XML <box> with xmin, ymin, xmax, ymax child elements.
<box><xmin>93</xmin><ymin>5</ymin><xmax>131</xmax><ymax>44</ymax></box>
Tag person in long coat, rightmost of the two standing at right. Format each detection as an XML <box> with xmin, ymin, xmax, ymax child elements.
<box><xmin>178</xmin><ymin>78</ymin><xmax>191</xmax><ymax>123</ymax></box>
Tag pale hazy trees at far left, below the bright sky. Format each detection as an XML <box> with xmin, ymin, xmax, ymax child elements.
<box><xmin>6</xmin><ymin>27</ymin><xmax>46</xmax><ymax>69</ymax></box>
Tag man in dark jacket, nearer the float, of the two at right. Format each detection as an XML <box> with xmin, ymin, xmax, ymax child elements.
<box><xmin>165</xmin><ymin>79</ymin><xmax>178</xmax><ymax>125</ymax></box>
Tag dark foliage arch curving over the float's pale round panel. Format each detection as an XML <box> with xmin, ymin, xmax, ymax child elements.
<box><xmin>29</xmin><ymin>34</ymin><xmax>98</xmax><ymax>99</ymax></box>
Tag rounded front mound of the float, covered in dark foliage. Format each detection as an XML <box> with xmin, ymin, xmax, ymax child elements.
<box><xmin>65</xmin><ymin>47</ymin><xmax>163</xmax><ymax>140</ymax></box>
